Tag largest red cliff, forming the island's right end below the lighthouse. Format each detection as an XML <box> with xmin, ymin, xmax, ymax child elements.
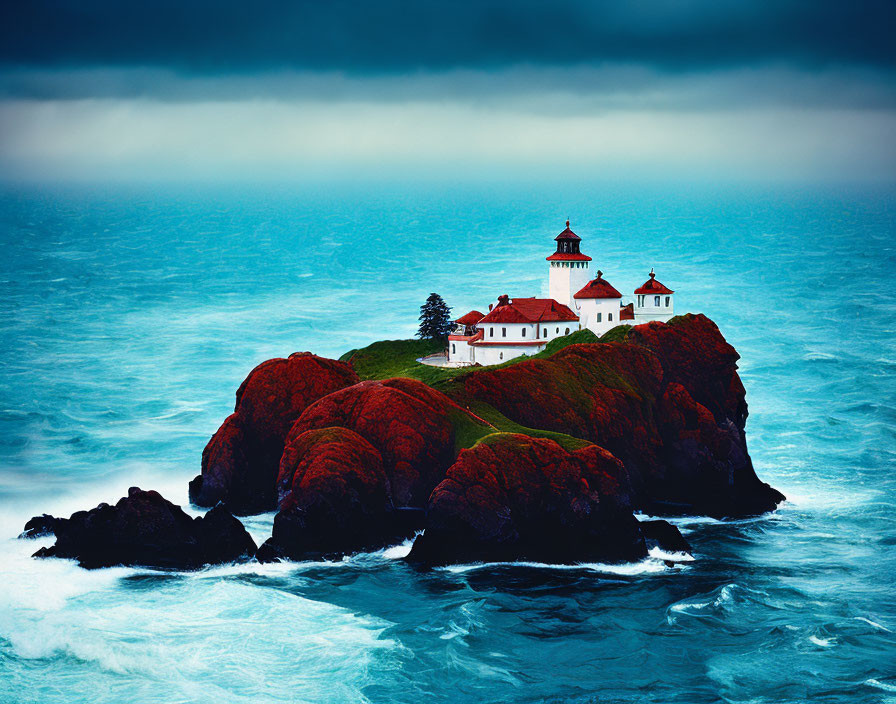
<box><xmin>452</xmin><ymin>315</ymin><xmax>784</xmax><ymax>516</ymax></box>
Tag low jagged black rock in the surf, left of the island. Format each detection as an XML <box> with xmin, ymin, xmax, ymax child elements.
<box><xmin>26</xmin><ymin>487</ymin><xmax>256</xmax><ymax>569</ymax></box>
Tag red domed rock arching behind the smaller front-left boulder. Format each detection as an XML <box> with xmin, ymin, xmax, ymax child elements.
<box><xmin>287</xmin><ymin>379</ymin><xmax>488</xmax><ymax>508</ymax></box>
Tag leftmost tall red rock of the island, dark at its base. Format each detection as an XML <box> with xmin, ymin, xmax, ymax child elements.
<box><xmin>190</xmin><ymin>352</ymin><xmax>358</xmax><ymax>515</ymax></box>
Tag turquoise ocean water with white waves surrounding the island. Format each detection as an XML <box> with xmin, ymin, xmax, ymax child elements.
<box><xmin>0</xmin><ymin>183</ymin><xmax>896</xmax><ymax>704</ymax></box>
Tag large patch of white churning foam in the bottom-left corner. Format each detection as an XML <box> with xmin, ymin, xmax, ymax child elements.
<box><xmin>0</xmin><ymin>541</ymin><xmax>396</xmax><ymax>702</ymax></box>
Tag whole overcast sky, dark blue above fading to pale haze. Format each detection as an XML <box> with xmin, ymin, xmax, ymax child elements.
<box><xmin>0</xmin><ymin>0</ymin><xmax>896</xmax><ymax>182</ymax></box>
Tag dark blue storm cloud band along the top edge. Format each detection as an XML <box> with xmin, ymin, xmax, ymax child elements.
<box><xmin>0</xmin><ymin>0</ymin><xmax>896</xmax><ymax>75</ymax></box>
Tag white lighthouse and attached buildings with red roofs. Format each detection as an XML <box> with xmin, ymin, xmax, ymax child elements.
<box><xmin>438</xmin><ymin>220</ymin><xmax>675</xmax><ymax>367</ymax></box>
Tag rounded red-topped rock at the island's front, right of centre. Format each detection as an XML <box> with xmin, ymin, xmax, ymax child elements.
<box><xmin>408</xmin><ymin>433</ymin><xmax>647</xmax><ymax>565</ymax></box>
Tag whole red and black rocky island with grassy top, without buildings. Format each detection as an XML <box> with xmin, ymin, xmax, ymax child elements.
<box><xmin>23</xmin><ymin>314</ymin><xmax>784</xmax><ymax>568</ymax></box>
